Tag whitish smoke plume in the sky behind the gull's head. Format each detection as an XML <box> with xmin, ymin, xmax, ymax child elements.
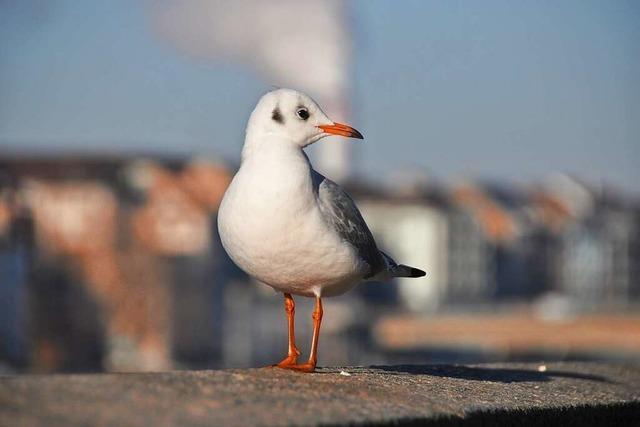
<box><xmin>149</xmin><ymin>0</ymin><xmax>352</xmax><ymax>180</ymax></box>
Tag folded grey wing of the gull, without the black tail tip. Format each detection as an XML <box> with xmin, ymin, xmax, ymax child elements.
<box><xmin>313</xmin><ymin>171</ymin><xmax>386</xmax><ymax>279</ymax></box>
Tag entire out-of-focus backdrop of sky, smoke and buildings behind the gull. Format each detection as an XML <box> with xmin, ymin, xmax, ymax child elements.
<box><xmin>0</xmin><ymin>0</ymin><xmax>640</xmax><ymax>373</ymax></box>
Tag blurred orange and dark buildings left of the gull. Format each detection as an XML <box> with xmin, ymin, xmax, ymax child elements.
<box><xmin>0</xmin><ymin>158</ymin><xmax>230</xmax><ymax>371</ymax></box>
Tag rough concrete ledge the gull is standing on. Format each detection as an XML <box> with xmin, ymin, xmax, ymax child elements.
<box><xmin>0</xmin><ymin>363</ymin><xmax>640</xmax><ymax>426</ymax></box>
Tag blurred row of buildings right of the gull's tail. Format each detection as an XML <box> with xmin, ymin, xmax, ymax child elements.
<box><xmin>353</xmin><ymin>175</ymin><xmax>640</xmax><ymax>313</ymax></box>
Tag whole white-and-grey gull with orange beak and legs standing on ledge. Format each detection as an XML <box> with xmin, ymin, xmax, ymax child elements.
<box><xmin>218</xmin><ymin>89</ymin><xmax>425</xmax><ymax>372</ymax></box>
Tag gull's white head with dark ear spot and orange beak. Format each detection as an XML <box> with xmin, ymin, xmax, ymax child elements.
<box><xmin>245</xmin><ymin>89</ymin><xmax>363</xmax><ymax>153</ymax></box>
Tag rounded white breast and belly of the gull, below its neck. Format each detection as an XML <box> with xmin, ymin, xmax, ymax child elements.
<box><xmin>218</xmin><ymin>144</ymin><xmax>362</xmax><ymax>296</ymax></box>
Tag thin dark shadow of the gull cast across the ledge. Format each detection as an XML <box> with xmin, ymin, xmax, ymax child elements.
<box><xmin>362</xmin><ymin>365</ymin><xmax>612</xmax><ymax>383</ymax></box>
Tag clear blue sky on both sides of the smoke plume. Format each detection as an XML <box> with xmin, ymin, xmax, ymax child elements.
<box><xmin>0</xmin><ymin>0</ymin><xmax>640</xmax><ymax>194</ymax></box>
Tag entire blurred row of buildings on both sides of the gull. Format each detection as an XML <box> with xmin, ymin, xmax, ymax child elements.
<box><xmin>0</xmin><ymin>156</ymin><xmax>640</xmax><ymax>372</ymax></box>
